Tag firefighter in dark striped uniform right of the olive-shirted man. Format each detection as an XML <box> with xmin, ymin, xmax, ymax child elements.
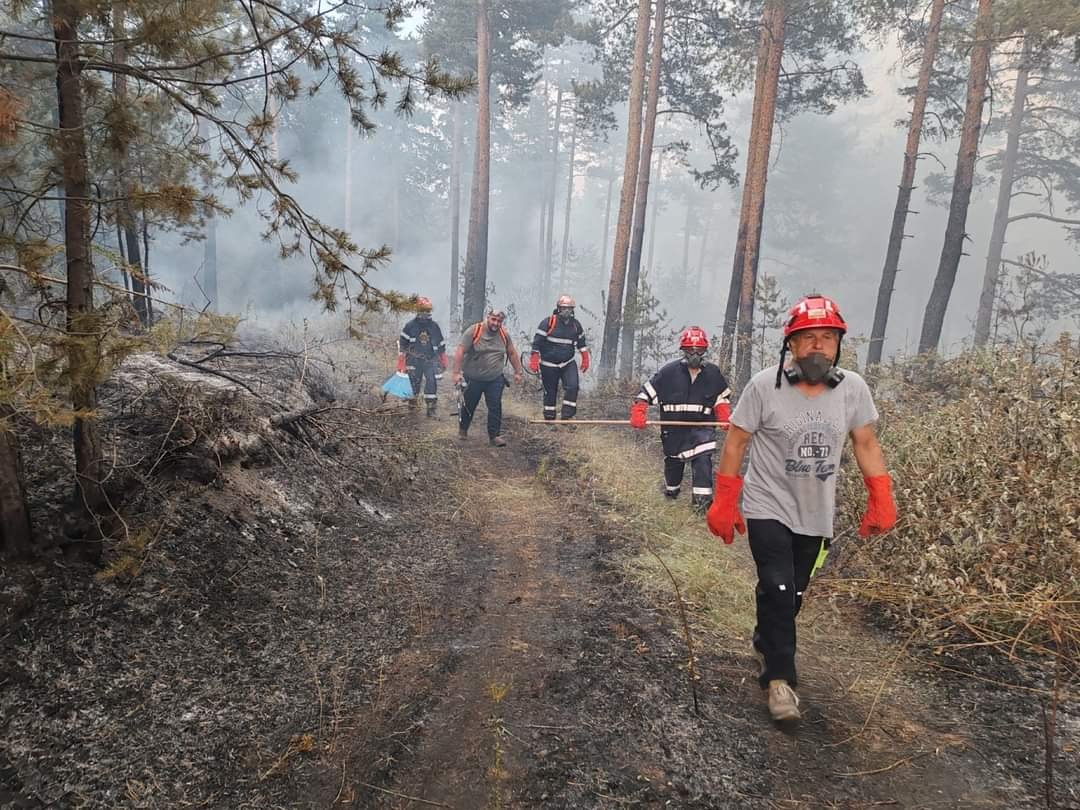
<box><xmin>529</xmin><ymin>295</ymin><xmax>589</xmax><ymax>420</ymax></box>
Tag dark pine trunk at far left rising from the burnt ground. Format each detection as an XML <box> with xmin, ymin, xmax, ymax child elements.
<box><xmin>52</xmin><ymin>0</ymin><xmax>105</xmax><ymax>539</ymax></box>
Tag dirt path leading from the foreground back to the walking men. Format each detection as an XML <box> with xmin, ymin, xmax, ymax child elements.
<box><xmin>340</xmin><ymin>414</ymin><xmax>1071</xmax><ymax>810</ymax></box>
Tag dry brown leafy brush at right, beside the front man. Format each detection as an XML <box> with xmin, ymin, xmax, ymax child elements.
<box><xmin>826</xmin><ymin>341</ymin><xmax>1080</xmax><ymax>680</ymax></box>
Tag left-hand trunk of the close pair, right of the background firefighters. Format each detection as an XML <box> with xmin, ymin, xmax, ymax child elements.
<box><xmin>600</xmin><ymin>0</ymin><xmax>650</xmax><ymax>375</ymax></box>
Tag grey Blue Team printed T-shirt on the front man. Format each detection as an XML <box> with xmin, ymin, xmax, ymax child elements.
<box><xmin>731</xmin><ymin>366</ymin><xmax>878</xmax><ymax>537</ymax></box>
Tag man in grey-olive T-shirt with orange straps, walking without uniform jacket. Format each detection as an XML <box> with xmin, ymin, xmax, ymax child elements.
<box><xmin>454</xmin><ymin>310</ymin><xmax>522</xmax><ymax>447</ymax></box>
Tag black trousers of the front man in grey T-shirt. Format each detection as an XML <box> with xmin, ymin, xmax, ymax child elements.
<box><xmin>746</xmin><ymin>518</ymin><xmax>828</xmax><ymax>689</ymax></box>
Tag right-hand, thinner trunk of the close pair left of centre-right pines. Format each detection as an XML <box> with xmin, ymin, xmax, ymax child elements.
<box><xmin>619</xmin><ymin>0</ymin><xmax>667</xmax><ymax>379</ymax></box>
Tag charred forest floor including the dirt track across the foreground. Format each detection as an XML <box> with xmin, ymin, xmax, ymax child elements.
<box><xmin>0</xmin><ymin>356</ymin><xmax>1080</xmax><ymax>810</ymax></box>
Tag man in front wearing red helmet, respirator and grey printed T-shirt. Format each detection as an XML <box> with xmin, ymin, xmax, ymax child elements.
<box><xmin>706</xmin><ymin>295</ymin><xmax>896</xmax><ymax>721</ymax></box>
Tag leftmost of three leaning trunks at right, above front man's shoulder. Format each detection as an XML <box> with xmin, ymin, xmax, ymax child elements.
<box><xmin>866</xmin><ymin>0</ymin><xmax>945</xmax><ymax>366</ymax></box>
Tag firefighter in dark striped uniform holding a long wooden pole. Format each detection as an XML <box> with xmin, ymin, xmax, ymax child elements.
<box><xmin>630</xmin><ymin>326</ymin><xmax>731</xmax><ymax>510</ymax></box>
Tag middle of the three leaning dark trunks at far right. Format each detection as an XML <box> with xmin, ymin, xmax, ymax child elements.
<box><xmin>919</xmin><ymin>0</ymin><xmax>993</xmax><ymax>354</ymax></box>
